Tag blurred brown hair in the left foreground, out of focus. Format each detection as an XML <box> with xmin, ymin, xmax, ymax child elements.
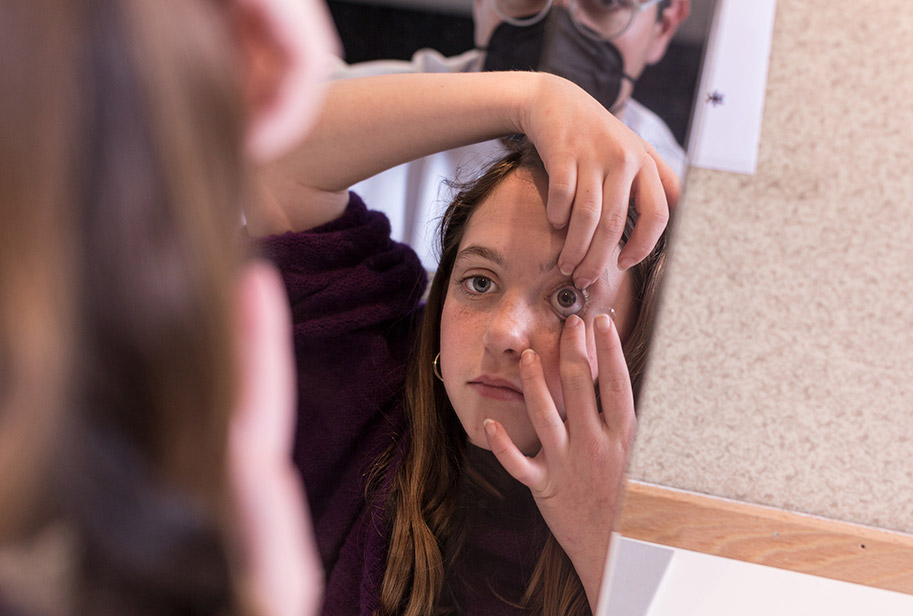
<box><xmin>0</xmin><ymin>0</ymin><xmax>245</xmax><ymax>614</ymax></box>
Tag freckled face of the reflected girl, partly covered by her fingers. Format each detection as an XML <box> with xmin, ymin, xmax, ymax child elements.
<box><xmin>440</xmin><ymin>170</ymin><xmax>635</xmax><ymax>454</ymax></box>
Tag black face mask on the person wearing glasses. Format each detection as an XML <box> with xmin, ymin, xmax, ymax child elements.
<box><xmin>483</xmin><ymin>7</ymin><xmax>634</xmax><ymax>109</ymax></box>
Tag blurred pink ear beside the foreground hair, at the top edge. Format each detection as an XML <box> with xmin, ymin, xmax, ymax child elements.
<box><xmin>233</xmin><ymin>0</ymin><xmax>338</xmax><ymax>162</ymax></box>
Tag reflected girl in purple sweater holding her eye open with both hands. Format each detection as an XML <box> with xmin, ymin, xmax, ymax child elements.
<box><xmin>253</xmin><ymin>72</ymin><xmax>678</xmax><ymax>616</ymax></box>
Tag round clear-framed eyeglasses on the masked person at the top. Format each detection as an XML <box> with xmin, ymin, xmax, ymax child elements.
<box><xmin>494</xmin><ymin>0</ymin><xmax>662</xmax><ymax>41</ymax></box>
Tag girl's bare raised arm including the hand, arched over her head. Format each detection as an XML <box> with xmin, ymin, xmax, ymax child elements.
<box><xmin>246</xmin><ymin>72</ymin><xmax>678</xmax><ymax>278</ymax></box>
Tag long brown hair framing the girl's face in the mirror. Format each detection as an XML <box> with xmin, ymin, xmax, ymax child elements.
<box><xmin>381</xmin><ymin>140</ymin><xmax>665</xmax><ymax>616</ymax></box>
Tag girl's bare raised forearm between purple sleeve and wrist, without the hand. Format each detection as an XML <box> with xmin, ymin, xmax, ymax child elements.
<box><xmin>248</xmin><ymin>72</ymin><xmax>556</xmax><ymax>235</ymax></box>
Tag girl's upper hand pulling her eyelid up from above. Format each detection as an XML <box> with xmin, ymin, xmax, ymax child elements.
<box><xmin>524</xmin><ymin>75</ymin><xmax>678</xmax><ymax>288</ymax></box>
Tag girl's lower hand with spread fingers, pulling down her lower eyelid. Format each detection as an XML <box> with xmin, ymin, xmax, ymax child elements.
<box><xmin>485</xmin><ymin>315</ymin><xmax>635</xmax><ymax>605</ymax></box>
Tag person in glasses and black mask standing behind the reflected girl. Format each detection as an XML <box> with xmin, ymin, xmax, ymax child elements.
<box><xmin>333</xmin><ymin>0</ymin><xmax>691</xmax><ymax>270</ymax></box>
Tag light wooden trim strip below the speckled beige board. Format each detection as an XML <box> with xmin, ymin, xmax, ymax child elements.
<box><xmin>618</xmin><ymin>480</ymin><xmax>913</xmax><ymax>595</ymax></box>
